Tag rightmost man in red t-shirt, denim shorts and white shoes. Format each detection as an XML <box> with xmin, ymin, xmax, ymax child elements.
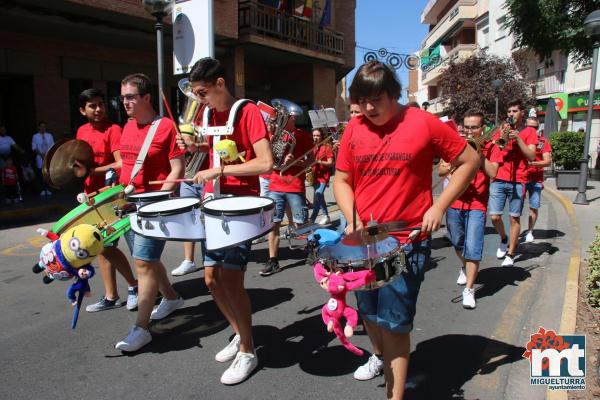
<box><xmin>525</xmin><ymin>117</ymin><xmax>552</xmax><ymax>243</ymax></box>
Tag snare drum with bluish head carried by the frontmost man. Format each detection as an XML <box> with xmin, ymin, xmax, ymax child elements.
<box><xmin>317</xmin><ymin>237</ymin><xmax>406</xmax><ymax>290</ymax></box>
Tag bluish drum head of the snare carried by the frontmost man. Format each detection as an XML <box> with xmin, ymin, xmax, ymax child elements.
<box><xmin>317</xmin><ymin>237</ymin><xmax>400</xmax><ymax>264</ymax></box>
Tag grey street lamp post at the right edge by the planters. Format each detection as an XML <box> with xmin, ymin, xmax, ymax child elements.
<box><xmin>573</xmin><ymin>10</ymin><xmax>600</xmax><ymax>205</ymax></box>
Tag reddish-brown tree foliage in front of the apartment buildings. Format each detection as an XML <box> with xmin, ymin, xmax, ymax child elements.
<box><xmin>438</xmin><ymin>51</ymin><xmax>534</xmax><ymax>121</ymax></box>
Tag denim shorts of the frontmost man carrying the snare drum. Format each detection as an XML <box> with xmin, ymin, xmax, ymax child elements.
<box><xmin>356</xmin><ymin>239</ymin><xmax>431</xmax><ymax>333</ymax></box>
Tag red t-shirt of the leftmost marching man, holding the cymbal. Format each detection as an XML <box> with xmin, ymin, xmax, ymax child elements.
<box><xmin>76</xmin><ymin>121</ymin><xmax>121</xmax><ymax>193</ymax></box>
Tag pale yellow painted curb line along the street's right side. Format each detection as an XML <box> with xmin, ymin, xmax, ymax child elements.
<box><xmin>544</xmin><ymin>186</ymin><xmax>581</xmax><ymax>400</ymax></box>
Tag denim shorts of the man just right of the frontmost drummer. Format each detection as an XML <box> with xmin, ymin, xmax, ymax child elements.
<box><xmin>446</xmin><ymin>208</ymin><xmax>485</xmax><ymax>261</ymax></box>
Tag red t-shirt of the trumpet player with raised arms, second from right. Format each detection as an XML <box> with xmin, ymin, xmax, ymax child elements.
<box><xmin>494</xmin><ymin>126</ymin><xmax>538</xmax><ymax>183</ymax></box>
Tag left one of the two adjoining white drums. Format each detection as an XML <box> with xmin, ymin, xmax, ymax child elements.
<box><xmin>129</xmin><ymin>197</ymin><xmax>206</xmax><ymax>242</ymax></box>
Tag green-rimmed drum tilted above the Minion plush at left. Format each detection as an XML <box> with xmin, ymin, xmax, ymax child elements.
<box><xmin>51</xmin><ymin>185</ymin><xmax>129</xmax><ymax>245</ymax></box>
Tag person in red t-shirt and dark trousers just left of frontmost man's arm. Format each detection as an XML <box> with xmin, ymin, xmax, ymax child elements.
<box><xmin>310</xmin><ymin>129</ymin><xmax>333</xmax><ymax>225</ymax></box>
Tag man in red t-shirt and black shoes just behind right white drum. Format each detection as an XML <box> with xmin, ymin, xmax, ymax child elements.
<box><xmin>259</xmin><ymin>115</ymin><xmax>313</xmax><ymax>276</ymax></box>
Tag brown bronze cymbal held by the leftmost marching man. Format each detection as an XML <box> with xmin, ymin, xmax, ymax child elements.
<box><xmin>42</xmin><ymin>139</ymin><xmax>94</xmax><ymax>189</ymax></box>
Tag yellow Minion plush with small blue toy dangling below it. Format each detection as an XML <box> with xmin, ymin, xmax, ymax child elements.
<box><xmin>33</xmin><ymin>224</ymin><xmax>104</xmax><ymax>329</ymax></box>
